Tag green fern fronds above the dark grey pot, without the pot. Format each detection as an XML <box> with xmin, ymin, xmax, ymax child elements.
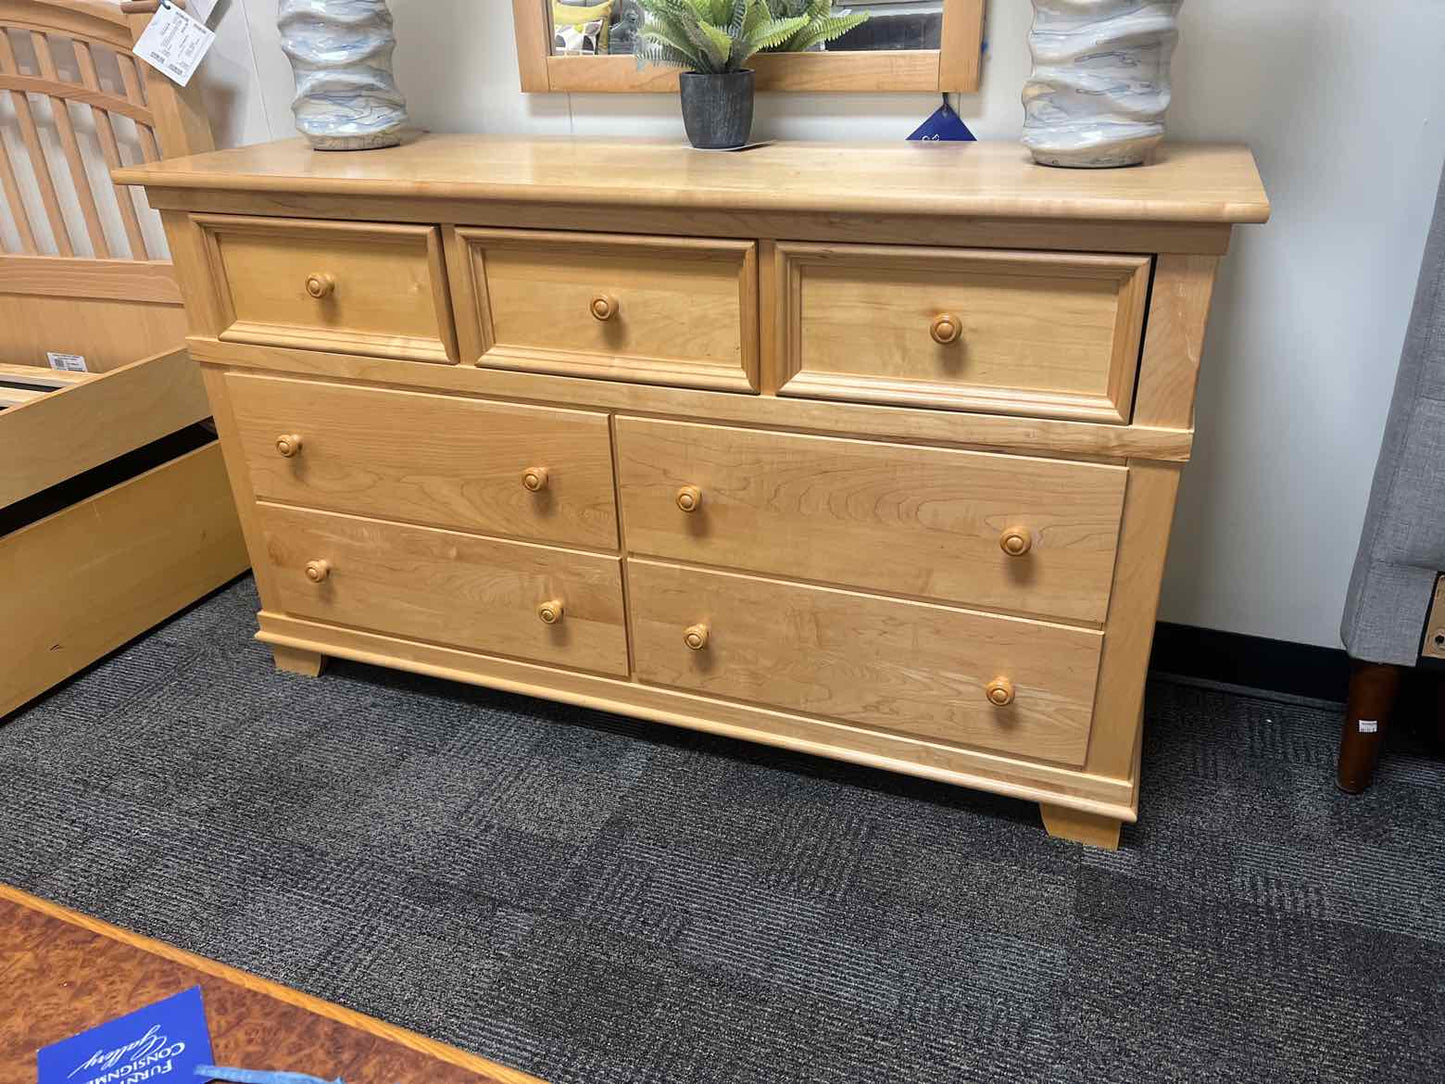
<box><xmin>637</xmin><ymin>0</ymin><xmax>820</xmax><ymax>74</ymax></box>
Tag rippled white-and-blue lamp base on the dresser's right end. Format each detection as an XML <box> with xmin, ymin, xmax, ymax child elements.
<box><xmin>1023</xmin><ymin>0</ymin><xmax>1182</xmax><ymax>168</ymax></box>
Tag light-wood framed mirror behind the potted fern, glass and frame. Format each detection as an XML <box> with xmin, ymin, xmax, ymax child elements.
<box><xmin>512</xmin><ymin>0</ymin><xmax>984</xmax><ymax>94</ymax></box>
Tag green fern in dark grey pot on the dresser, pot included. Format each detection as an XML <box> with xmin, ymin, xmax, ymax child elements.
<box><xmin>637</xmin><ymin>0</ymin><xmax>867</xmax><ymax>150</ymax></box>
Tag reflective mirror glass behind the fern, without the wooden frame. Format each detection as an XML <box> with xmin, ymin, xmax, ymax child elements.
<box><xmin>539</xmin><ymin>0</ymin><xmax>944</xmax><ymax>56</ymax></box>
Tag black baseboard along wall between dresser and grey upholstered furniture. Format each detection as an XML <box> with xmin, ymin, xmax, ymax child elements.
<box><xmin>1149</xmin><ymin>621</ymin><xmax>1350</xmax><ymax>702</ymax></box>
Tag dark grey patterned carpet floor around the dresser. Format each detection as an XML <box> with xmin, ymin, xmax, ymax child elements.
<box><xmin>0</xmin><ymin>580</ymin><xmax>1445</xmax><ymax>1084</ymax></box>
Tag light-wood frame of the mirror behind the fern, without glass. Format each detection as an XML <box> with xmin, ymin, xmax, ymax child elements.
<box><xmin>512</xmin><ymin>0</ymin><xmax>984</xmax><ymax>94</ymax></box>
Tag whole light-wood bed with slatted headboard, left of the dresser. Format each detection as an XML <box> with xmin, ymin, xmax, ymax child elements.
<box><xmin>0</xmin><ymin>0</ymin><xmax>247</xmax><ymax>717</ymax></box>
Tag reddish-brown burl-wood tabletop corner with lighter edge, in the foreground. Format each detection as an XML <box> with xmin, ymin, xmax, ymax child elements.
<box><xmin>0</xmin><ymin>885</ymin><xmax>540</xmax><ymax>1084</ymax></box>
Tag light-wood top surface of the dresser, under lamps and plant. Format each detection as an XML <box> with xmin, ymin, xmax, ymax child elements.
<box><xmin>116</xmin><ymin>134</ymin><xmax>1269</xmax><ymax>224</ymax></box>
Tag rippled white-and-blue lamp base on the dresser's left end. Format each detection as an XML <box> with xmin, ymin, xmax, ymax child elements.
<box><xmin>276</xmin><ymin>0</ymin><xmax>406</xmax><ymax>150</ymax></box>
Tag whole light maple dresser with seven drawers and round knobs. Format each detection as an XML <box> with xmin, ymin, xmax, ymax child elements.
<box><xmin>118</xmin><ymin>136</ymin><xmax>1269</xmax><ymax>846</ymax></box>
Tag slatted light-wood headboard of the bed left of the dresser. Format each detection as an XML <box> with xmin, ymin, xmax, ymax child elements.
<box><xmin>0</xmin><ymin>0</ymin><xmax>214</xmax><ymax>371</ymax></box>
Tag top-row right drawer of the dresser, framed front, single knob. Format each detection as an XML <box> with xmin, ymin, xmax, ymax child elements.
<box><xmin>775</xmin><ymin>241</ymin><xmax>1149</xmax><ymax>422</ymax></box>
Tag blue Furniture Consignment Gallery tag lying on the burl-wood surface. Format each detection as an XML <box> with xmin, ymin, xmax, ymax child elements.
<box><xmin>35</xmin><ymin>986</ymin><xmax>211</xmax><ymax>1084</ymax></box>
